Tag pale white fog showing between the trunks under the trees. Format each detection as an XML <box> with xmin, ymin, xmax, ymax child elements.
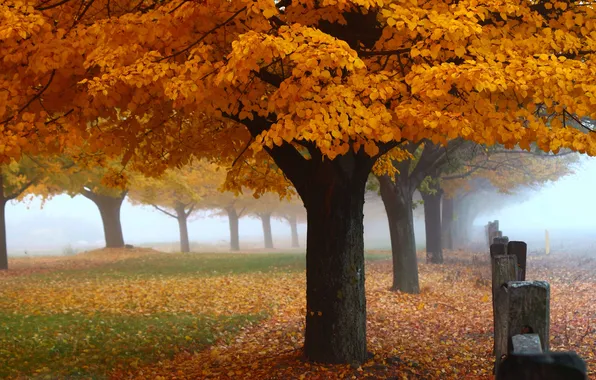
<box><xmin>6</xmin><ymin>157</ymin><xmax>596</xmax><ymax>256</ymax></box>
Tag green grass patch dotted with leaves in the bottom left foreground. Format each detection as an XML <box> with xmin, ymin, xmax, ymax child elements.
<box><xmin>0</xmin><ymin>313</ymin><xmax>264</xmax><ymax>379</ymax></box>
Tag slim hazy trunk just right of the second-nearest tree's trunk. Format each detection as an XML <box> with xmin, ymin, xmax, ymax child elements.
<box><xmin>421</xmin><ymin>185</ymin><xmax>443</xmax><ymax>264</ymax></box>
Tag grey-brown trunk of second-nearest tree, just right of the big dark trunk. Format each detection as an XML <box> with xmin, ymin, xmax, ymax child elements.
<box><xmin>379</xmin><ymin>178</ymin><xmax>420</xmax><ymax>294</ymax></box>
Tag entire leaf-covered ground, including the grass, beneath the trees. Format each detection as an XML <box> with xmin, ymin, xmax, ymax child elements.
<box><xmin>0</xmin><ymin>250</ymin><xmax>596</xmax><ymax>379</ymax></box>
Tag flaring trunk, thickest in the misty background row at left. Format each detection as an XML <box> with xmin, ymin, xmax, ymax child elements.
<box><xmin>81</xmin><ymin>190</ymin><xmax>126</xmax><ymax>248</ymax></box>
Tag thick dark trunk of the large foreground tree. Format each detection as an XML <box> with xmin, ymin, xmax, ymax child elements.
<box><xmin>301</xmin><ymin>156</ymin><xmax>373</xmax><ymax>363</ymax></box>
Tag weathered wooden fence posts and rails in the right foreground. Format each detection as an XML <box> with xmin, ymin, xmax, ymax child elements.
<box><xmin>486</xmin><ymin>221</ymin><xmax>588</xmax><ymax>380</ymax></box>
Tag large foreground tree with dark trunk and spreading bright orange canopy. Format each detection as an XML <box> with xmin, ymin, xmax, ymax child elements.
<box><xmin>0</xmin><ymin>0</ymin><xmax>596</xmax><ymax>363</ymax></box>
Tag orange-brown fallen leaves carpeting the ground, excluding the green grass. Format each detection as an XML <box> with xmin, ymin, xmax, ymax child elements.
<box><xmin>0</xmin><ymin>252</ymin><xmax>596</xmax><ymax>379</ymax></box>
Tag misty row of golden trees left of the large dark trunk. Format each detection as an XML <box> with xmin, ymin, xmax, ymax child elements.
<box><xmin>0</xmin><ymin>157</ymin><xmax>305</xmax><ymax>264</ymax></box>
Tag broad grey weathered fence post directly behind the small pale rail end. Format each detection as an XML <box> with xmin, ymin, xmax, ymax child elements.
<box><xmin>494</xmin><ymin>280</ymin><xmax>550</xmax><ymax>368</ymax></box>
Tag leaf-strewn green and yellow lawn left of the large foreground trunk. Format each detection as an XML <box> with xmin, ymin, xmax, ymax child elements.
<box><xmin>0</xmin><ymin>254</ymin><xmax>305</xmax><ymax>379</ymax></box>
